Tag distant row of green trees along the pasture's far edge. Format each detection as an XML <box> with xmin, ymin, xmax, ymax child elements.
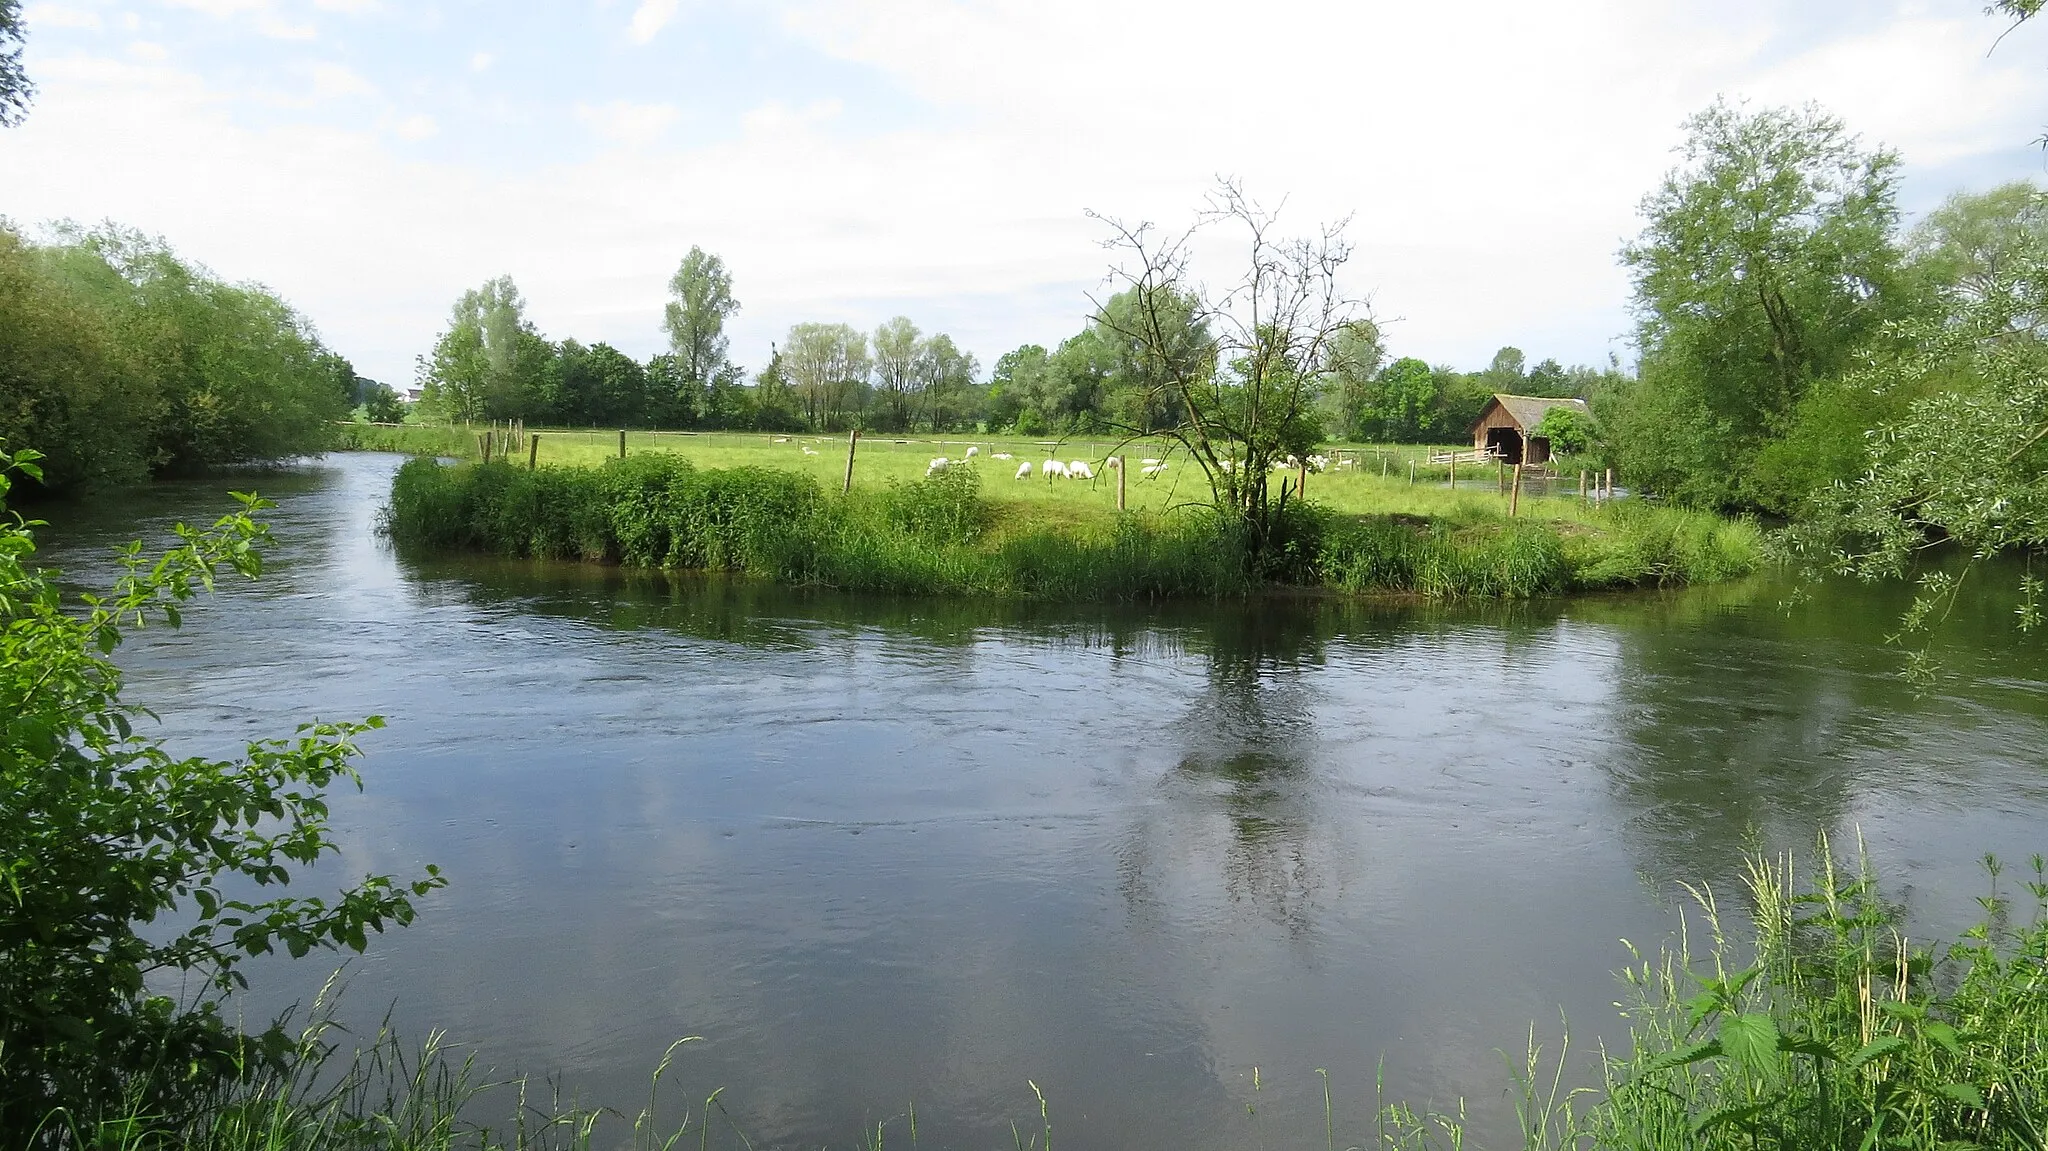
<box><xmin>411</xmin><ymin>248</ymin><xmax>1618</xmax><ymax>442</ymax></box>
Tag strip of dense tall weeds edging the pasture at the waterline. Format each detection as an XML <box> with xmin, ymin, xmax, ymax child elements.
<box><xmin>389</xmin><ymin>453</ymin><xmax>1761</xmax><ymax>600</ymax></box>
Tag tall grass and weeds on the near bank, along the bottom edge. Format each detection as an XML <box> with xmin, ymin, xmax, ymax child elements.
<box><xmin>47</xmin><ymin>842</ymin><xmax>2048</xmax><ymax>1151</ymax></box>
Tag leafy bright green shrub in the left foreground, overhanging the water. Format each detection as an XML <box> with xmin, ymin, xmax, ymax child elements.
<box><xmin>0</xmin><ymin>451</ymin><xmax>444</xmax><ymax>1145</ymax></box>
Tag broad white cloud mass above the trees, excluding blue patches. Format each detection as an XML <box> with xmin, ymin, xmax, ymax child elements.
<box><xmin>0</xmin><ymin>0</ymin><xmax>2048</xmax><ymax>387</ymax></box>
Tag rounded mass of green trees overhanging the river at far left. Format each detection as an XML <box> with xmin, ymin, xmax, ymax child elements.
<box><xmin>0</xmin><ymin>223</ymin><xmax>369</xmax><ymax>492</ymax></box>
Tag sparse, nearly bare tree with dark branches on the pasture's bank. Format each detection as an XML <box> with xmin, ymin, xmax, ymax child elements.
<box><xmin>1092</xmin><ymin>180</ymin><xmax>1370</xmax><ymax>563</ymax></box>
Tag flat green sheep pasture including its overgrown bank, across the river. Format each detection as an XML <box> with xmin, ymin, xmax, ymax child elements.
<box><xmin>380</xmin><ymin>428</ymin><xmax>1763</xmax><ymax>600</ymax></box>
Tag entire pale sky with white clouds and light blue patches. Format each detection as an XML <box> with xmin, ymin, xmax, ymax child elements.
<box><xmin>0</xmin><ymin>0</ymin><xmax>2048</xmax><ymax>385</ymax></box>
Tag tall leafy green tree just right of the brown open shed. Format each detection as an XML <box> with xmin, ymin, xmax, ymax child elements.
<box><xmin>1610</xmin><ymin>102</ymin><xmax>1903</xmax><ymax>510</ymax></box>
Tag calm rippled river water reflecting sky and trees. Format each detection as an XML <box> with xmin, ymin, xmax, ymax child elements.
<box><xmin>28</xmin><ymin>455</ymin><xmax>2048</xmax><ymax>1147</ymax></box>
